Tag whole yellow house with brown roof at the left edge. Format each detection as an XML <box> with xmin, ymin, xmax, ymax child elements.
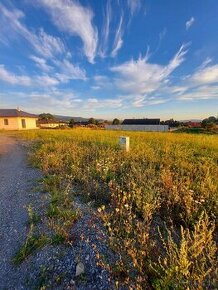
<box><xmin>0</xmin><ymin>109</ymin><xmax>38</xmax><ymax>130</ymax></box>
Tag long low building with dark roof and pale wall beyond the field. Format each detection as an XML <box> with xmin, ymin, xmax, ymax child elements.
<box><xmin>105</xmin><ymin>119</ymin><xmax>169</xmax><ymax>132</ymax></box>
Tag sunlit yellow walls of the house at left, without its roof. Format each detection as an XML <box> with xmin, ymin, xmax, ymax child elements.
<box><xmin>0</xmin><ymin>117</ymin><xmax>37</xmax><ymax>130</ymax></box>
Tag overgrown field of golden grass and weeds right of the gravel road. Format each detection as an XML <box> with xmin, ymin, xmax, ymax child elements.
<box><xmin>12</xmin><ymin>129</ymin><xmax>218</xmax><ymax>289</ymax></box>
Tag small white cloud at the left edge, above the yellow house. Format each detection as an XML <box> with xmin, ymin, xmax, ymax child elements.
<box><xmin>0</xmin><ymin>65</ymin><xmax>32</xmax><ymax>86</ymax></box>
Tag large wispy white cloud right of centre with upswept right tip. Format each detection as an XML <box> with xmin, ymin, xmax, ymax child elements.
<box><xmin>111</xmin><ymin>45</ymin><xmax>187</xmax><ymax>108</ymax></box>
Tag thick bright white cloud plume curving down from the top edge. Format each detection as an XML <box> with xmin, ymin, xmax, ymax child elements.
<box><xmin>37</xmin><ymin>0</ymin><xmax>98</xmax><ymax>63</ymax></box>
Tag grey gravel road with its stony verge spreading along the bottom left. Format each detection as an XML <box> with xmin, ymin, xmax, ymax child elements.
<box><xmin>0</xmin><ymin>135</ymin><xmax>115</xmax><ymax>290</ymax></box>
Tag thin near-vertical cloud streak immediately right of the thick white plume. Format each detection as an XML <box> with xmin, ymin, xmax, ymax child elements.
<box><xmin>99</xmin><ymin>0</ymin><xmax>112</xmax><ymax>57</ymax></box>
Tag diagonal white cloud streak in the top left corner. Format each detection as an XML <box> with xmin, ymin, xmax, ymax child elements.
<box><xmin>0</xmin><ymin>3</ymin><xmax>65</xmax><ymax>58</ymax></box>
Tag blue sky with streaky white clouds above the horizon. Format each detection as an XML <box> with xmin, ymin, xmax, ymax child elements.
<box><xmin>0</xmin><ymin>0</ymin><xmax>218</xmax><ymax>120</ymax></box>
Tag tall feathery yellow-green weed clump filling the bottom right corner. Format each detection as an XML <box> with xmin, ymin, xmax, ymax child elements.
<box><xmin>153</xmin><ymin>214</ymin><xmax>217</xmax><ymax>289</ymax></box>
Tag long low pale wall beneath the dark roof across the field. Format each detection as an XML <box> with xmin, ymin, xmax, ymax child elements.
<box><xmin>105</xmin><ymin>125</ymin><xmax>169</xmax><ymax>132</ymax></box>
